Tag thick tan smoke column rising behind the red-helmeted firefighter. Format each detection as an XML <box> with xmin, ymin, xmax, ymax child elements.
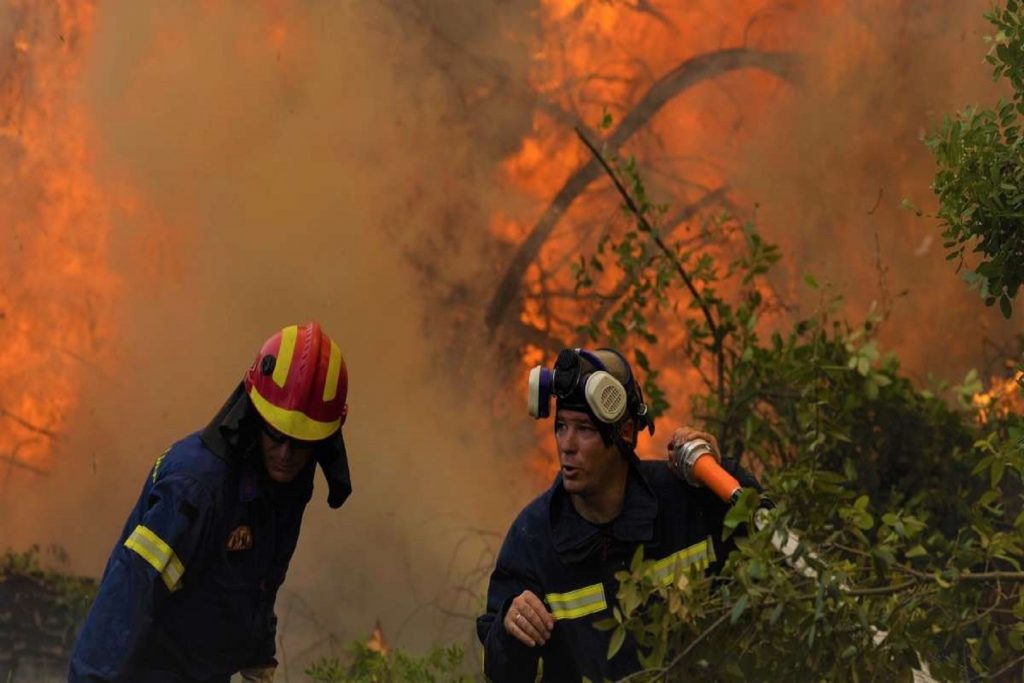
<box><xmin>0</xmin><ymin>1</ymin><xmax>534</xmax><ymax>673</ymax></box>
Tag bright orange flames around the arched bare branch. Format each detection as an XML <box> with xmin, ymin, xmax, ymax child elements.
<box><xmin>488</xmin><ymin>0</ymin><xmax>836</xmax><ymax>476</ymax></box>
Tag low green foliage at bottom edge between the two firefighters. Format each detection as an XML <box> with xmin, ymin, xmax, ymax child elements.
<box><xmin>306</xmin><ymin>642</ymin><xmax>473</xmax><ymax>683</ymax></box>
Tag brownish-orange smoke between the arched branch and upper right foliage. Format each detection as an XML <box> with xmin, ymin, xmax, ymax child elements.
<box><xmin>729</xmin><ymin>0</ymin><xmax>1021</xmax><ymax>380</ymax></box>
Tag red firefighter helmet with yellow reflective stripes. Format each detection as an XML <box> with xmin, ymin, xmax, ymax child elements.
<box><xmin>245</xmin><ymin>323</ymin><xmax>348</xmax><ymax>441</ymax></box>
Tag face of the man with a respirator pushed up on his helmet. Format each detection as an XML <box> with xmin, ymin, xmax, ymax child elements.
<box><xmin>555</xmin><ymin>410</ymin><xmax>629</xmax><ymax>498</ymax></box>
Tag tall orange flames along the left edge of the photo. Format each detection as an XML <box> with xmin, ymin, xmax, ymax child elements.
<box><xmin>0</xmin><ymin>0</ymin><xmax>117</xmax><ymax>476</ymax></box>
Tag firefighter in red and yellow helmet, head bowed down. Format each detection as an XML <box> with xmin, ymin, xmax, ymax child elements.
<box><xmin>70</xmin><ymin>323</ymin><xmax>351</xmax><ymax>683</ymax></box>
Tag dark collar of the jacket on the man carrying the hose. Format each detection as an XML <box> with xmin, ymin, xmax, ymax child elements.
<box><xmin>548</xmin><ymin>455</ymin><xmax>657</xmax><ymax>562</ymax></box>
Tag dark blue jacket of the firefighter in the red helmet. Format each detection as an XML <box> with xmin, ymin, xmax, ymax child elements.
<box><xmin>70</xmin><ymin>391</ymin><xmax>347</xmax><ymax>683</ymax></box>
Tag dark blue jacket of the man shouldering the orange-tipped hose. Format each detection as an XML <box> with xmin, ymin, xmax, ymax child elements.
<box><xmin>476</xmin><ymin>456</ymin><xmax>758</xmax><ymax>683</ymax></box>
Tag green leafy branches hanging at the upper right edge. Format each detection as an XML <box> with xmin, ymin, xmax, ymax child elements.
<box><xmin>927</xmin><ymin>0</ymin><xmax>1024</xmax><ymax>317</ymax></box>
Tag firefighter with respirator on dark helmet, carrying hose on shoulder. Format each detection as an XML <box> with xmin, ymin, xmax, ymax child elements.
<box><xmin>476</xmin><ymin>349</ymin><xmax>758</xmax><ymax>683</ymax></box>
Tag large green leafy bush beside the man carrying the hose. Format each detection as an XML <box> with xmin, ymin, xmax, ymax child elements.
<box><xmin>578</xmin><ymin>121</ymin><xmax>1024</xmax><ymax>681</ymax></box>
